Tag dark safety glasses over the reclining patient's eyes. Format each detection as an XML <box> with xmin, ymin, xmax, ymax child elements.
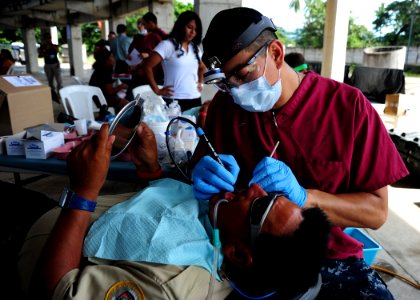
<box><xmin>249</xmin><ymin>194</ymin><xmax>280</xmax><ymax>248</ymax></box>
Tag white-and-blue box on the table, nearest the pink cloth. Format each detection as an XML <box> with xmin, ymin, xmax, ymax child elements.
<box><xmin>24</xmin><ymin>130</ymin><xmax>64</xmax><ymax>159</ymax></box>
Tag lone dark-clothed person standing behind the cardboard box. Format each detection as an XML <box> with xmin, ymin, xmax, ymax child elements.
<box><xmin>38</xmin><ymin>32</ymin><xmax>63</xmax><ymax>102</ymax></box>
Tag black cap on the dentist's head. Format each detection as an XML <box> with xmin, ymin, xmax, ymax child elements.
<box><xmin>203</xmin><ymin>7</ymin><xmax>277</xmax><ymax>65</ymax></box>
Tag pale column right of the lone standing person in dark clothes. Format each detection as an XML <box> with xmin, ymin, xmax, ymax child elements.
<box><xmin>67</xmin><ymin>25</ymin><xmax>86</xmax><ymax>78</ymax></box>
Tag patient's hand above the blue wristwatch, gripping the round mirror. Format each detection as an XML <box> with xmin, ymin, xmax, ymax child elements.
<box><xmin>67</xmin><ymin>123</ymin><xmax>115</xmax><ymax>200</ymax></box>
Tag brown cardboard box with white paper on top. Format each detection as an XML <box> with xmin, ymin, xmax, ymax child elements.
<box><xmin>0</xmin><ymin>75</ymin><xmax>54</xmax><ymax>136</ymax></box>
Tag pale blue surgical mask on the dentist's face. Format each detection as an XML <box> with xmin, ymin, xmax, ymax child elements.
<box><xmin>230</xmin><ymin>51</ymin><xmax>282</xmax><ymax>112</ymax></box>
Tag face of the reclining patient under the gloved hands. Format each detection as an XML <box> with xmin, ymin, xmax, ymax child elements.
<box><xmin>210</xmin><ymin>184</ymin><xmax>303</xmax><ymax>250</ymax></box>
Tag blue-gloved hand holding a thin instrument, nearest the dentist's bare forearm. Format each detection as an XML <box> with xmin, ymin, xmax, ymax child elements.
<box><xmin>249</xmin><ymin>157</ymin><xmax>306</xmax><ymax>207</ymax></box>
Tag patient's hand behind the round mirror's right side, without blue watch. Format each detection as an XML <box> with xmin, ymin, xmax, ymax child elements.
<box><xmin>128</xmin><ymin>123</ymin><xmax>160</xmax><ymax>173</ymax></box>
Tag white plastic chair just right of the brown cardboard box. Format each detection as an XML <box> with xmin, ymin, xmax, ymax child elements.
<box><xmin>59</xmin><ymin>84</ymin><xmax>115</xmax><ymax>120</ymax></box>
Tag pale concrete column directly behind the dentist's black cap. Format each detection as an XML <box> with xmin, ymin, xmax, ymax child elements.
<box><xmin>194</xmin><ymin>0</ymin><xmax>242</xmax><ymax>38</ymax></box>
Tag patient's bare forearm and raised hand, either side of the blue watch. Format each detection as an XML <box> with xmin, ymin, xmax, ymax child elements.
<box><xmin>33</xmin><ymin>124</ymin><xmax>114</xmax><ymax>299</ymax></box>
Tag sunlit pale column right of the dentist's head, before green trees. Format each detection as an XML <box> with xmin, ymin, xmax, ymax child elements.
<box><xmin>321</xmin><ymin>0</ymin><xmax>350</xmax><ymax>82</ymax></box>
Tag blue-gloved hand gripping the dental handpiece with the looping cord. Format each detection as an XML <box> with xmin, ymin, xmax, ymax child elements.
<box><xmin>192</xmin><ymin>154</ymin><xmax>239</xmax><ymax>200</ymax></box>
